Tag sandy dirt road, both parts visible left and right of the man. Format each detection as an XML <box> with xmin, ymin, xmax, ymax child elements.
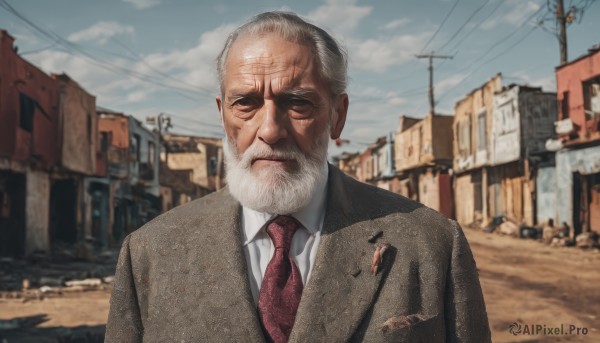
<box><xmin>0</xmin><ymin>229</ymin><xmax>600</xmax><ymax>342</ymax></box>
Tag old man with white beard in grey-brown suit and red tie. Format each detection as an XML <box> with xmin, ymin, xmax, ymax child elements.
<box><xmin>106</xmin><ymin>12</ymin><xmax>490</xmax><ymax>343</ymax></box>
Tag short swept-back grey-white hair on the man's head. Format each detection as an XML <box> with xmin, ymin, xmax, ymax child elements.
<box><xmin>217</xmin><ymin>11</ymin><xmax>348</xmax><ymax>97</ymax></box>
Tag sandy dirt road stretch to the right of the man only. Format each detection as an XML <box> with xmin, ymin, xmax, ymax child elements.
<box><xmin>465</xmin><ymin>229</ymin><xmax>600</xmax><ymax>342</ymax></box>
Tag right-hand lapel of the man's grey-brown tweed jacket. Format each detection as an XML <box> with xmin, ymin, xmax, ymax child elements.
<box><xmin>289</xmin><ymin>166</ymin><xmax>395</xmax><ymax>342</ymax></box>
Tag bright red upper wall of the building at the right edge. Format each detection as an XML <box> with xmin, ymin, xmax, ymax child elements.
<box><xmin>556</xmin><ymin>50</ymin><xmax>600</xmax><ymax>137</ymax></box>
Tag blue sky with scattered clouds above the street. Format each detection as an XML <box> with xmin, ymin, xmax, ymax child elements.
<box><xmin>0</xmin><ymin>0</ymin><xmax>600</xmax><ymax>154</ymax></box>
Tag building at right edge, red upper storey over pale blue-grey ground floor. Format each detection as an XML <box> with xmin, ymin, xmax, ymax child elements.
<box><xmin>555</xmin><ymin>45</ymin><xmax>600</xmax><ymax>237</ymax></box>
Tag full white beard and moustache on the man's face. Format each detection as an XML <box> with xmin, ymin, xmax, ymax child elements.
<box><xmin>223</xmin><ymin>127</ymin><xmax>329</xmax><ymax>214</ymax></box>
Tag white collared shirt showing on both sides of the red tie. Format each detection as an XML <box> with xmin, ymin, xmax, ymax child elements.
<box><xmin>242</xmin><ymin>163</ymin><xmax>328</xmax><ymax>304</ymax></box>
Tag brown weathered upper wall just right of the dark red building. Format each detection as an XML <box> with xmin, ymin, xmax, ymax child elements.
<box><xmin>53</xmin><ymin>74</ymin><xmax>98</xmax><ymax>175</ymax></box>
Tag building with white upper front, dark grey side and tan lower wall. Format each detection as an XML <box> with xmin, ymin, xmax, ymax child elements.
<box><xmin>488</xmin><ymin>84</ymin><xmax>556</xmax><ymax>226</ymax></box>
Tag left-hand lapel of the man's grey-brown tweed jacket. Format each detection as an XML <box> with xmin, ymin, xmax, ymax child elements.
<box><xmin>188</xmin><ymin>189</ymin><xmax>264</xmax><ymax>342</ymax></box>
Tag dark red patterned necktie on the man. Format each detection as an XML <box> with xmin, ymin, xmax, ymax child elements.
<box><xmin>258</xmin><ymin>216</ymin><xmax>303</xmax><ymax>343</ymax></box>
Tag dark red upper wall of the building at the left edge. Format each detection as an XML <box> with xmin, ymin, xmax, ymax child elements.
<box><xmin>0</xmin><ymin>30</ymin><xmax>58</xmax><ymax>167</ymax></box>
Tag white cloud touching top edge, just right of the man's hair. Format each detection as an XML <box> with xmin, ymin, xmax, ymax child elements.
<box><xmin>307</xmin><ymin>0</ymin><xmax>373</xmax><ymax>34</ymax></box>
